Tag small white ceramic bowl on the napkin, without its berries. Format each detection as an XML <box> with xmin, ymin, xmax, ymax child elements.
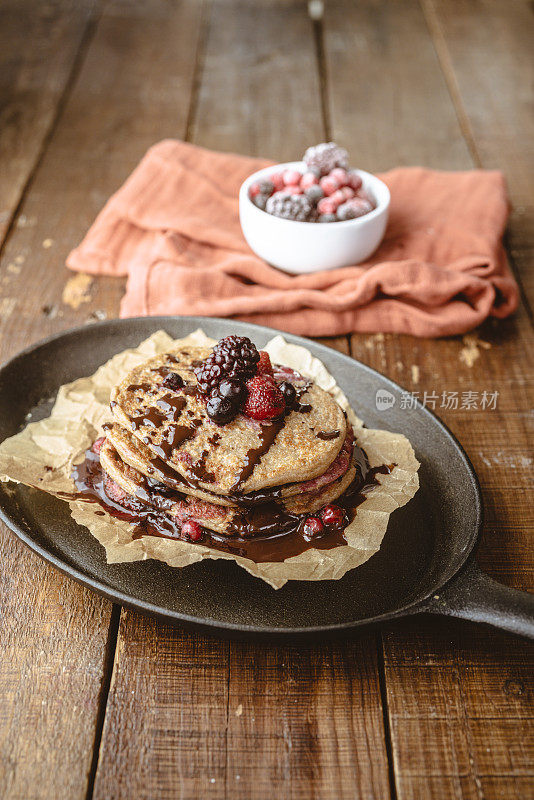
<box><xmin>239</xmin><ymin>161</ymin><xmax>390</xmax><ymax>273</ymax></box>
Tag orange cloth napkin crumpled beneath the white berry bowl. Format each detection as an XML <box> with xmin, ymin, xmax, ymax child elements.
<box><xmin>67</xmin><ymin>140</ymin><xmax>518</xmax><ymax>336</ymax></box>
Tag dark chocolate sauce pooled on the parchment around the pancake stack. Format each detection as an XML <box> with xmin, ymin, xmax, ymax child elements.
<box><xmin>69</xmin><ymin>448</ymin><xmax>392</xmax><ymax>563</ymax></box>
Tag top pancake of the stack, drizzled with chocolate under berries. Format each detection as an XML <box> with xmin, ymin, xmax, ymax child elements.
<box><xmin>112</xmin><ymin>346</ymin><xmax>347</xmax><ymax>495</ymax></box>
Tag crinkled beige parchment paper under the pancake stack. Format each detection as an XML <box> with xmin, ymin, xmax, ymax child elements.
<box><xmin>0</xmin><ymin>330</ymin><xmax>419</xmax><ymax>589</ymax></box>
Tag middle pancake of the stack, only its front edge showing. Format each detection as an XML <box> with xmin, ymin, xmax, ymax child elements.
<box><xmin>106</xmin><ymin>418</ymin><xmax>354</xmax><ymax>507</ymax></box>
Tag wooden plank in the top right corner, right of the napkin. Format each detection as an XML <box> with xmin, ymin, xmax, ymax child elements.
<box><xmin>422</xmin><ymin>0</ymin><xmax>534</xmax><ymax>305</ymax></box>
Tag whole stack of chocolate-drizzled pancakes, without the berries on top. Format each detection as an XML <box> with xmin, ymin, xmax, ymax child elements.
<box><xmin>100</xmin><ymin>346</ymin><xmax>356</xmax><ymax>536</ymax></box>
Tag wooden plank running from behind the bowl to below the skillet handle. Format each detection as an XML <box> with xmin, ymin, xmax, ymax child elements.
<box><xmin>325</xmin><ymin>2</ymin><xmax>533</xmax><ymax>800</ymax></box>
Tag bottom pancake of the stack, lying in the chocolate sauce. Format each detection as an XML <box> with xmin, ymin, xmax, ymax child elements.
<box><xmin>100</xmin><ymin>441</ymin><xmax>356</xmax><ymax>536</ymax></box>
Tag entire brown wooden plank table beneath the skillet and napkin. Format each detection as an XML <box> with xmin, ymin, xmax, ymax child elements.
<box><xmin>0</xmin><ymin>0</ymin><xmax>534</xmax><ymax>800</ymax></box>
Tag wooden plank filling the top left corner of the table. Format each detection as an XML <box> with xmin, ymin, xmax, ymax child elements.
<box><xmin>0</xmin><ymin>0</ymin><xmax>95</xmax><ymax>243</ymax></box>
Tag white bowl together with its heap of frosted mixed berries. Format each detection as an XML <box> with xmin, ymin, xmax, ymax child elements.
<box><xmin>239</xmin><ymin>142</ymin><xmax>390</xmax><ymax>273</ymax></box>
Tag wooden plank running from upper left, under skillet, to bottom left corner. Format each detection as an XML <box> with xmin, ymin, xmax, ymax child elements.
<box><xmin>0</xmin><ymin>0</ymin><xmax>201</xmax><ymax>800</ymax></box>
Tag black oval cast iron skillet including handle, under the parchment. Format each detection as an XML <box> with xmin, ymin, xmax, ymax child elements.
<box><xmin>0</xmin><ymin>317</ymin><xmax>534</xmax><ymax>641</ymax></box>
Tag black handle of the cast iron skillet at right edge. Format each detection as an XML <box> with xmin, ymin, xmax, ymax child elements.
<box><xmin>425</xmin><ymin>559</ymin><xmax>534</xmax><ymax>639</ymax></box>
